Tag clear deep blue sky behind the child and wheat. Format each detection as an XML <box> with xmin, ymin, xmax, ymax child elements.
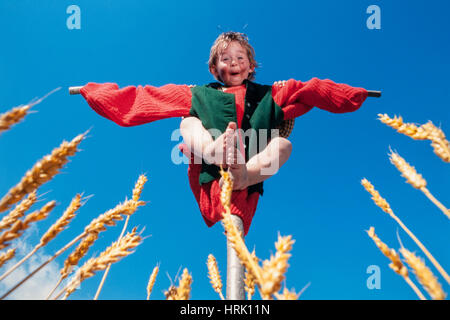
<box><xmin>0</xmin><ymin>0</ymin><xmax>450</xmax><ymax>299</ymax></box>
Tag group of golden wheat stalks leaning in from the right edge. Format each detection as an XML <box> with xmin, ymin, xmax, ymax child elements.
<box><xmin>361</xmin><ymin>114</ymin><xmax>450</xmax><ymax>300</ymax></box>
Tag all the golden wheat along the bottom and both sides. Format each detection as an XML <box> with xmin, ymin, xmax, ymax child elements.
<box><xmin>0</xmin><ymin>90</ymin><xmax>450</xmax><ymax>300</ymax></box>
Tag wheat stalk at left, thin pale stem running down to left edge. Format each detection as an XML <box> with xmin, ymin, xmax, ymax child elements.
<box><xmin>0</xmin><ymin>194</ymin><xmax>81</xmax><ymax>281</ymax></box>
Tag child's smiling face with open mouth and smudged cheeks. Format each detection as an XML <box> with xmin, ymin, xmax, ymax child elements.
<box><xmin>210</xmin><ymin>41</ymin><xmax>255</xmax><ymax>87</ymax></box>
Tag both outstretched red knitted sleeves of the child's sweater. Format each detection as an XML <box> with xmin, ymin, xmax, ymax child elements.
<box><xmin>80</xmin><ymin>78</ymin><xmax>367</xmax><ymax>127</ymax></box>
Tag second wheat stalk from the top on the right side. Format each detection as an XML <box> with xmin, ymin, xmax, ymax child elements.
<box><xmin>389</xmin><ymin>150</ymin><xmax>450</xmax><ymax>218</ymax></box>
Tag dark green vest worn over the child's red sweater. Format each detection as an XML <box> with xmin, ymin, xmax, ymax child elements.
<box><xmin>189</xmin><ymin>81</ymin><xmax>284</xmax><ymax>194</ymax></box>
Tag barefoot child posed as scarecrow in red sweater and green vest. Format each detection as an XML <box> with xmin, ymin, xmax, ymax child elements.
<box><xmin>80</xmin><ymin>32</ymin><xmax>368</xmax><ymax>234</ymax></box>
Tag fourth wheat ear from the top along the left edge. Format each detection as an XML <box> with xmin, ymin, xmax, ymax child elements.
<box><xmin>0</xmin><ymin>201</ymin><xmax>56</xmax><ymax>250</ymax></box>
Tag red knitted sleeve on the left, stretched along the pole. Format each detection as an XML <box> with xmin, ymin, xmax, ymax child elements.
<box><xmin>80</xmin><ymin>82</ymin><xmax>191</xmax><ymax>127</ymax></box>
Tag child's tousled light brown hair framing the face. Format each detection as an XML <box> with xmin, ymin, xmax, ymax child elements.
<box><xmin>208</xmin><ymin>31</ymin><xmax>258</xmax><ymax>81</ymax></box>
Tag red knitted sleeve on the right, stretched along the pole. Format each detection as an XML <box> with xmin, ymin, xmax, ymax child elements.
<box><xmin>272</xmin><ymin>78</ymin><xmax>367</xmax><ymax>119</ymax></box>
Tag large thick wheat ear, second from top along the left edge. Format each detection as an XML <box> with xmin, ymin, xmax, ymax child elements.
<box><xmin>0</xmin><ymin>132</ymin><xmax>87</xmax><ymax>212</ymax></box>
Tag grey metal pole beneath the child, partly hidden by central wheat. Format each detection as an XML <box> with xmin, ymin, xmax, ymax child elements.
<box><xmin>226</xmin><ymin>214</ymin><xmax>245</xmax><ymax>300</ymax></box>
